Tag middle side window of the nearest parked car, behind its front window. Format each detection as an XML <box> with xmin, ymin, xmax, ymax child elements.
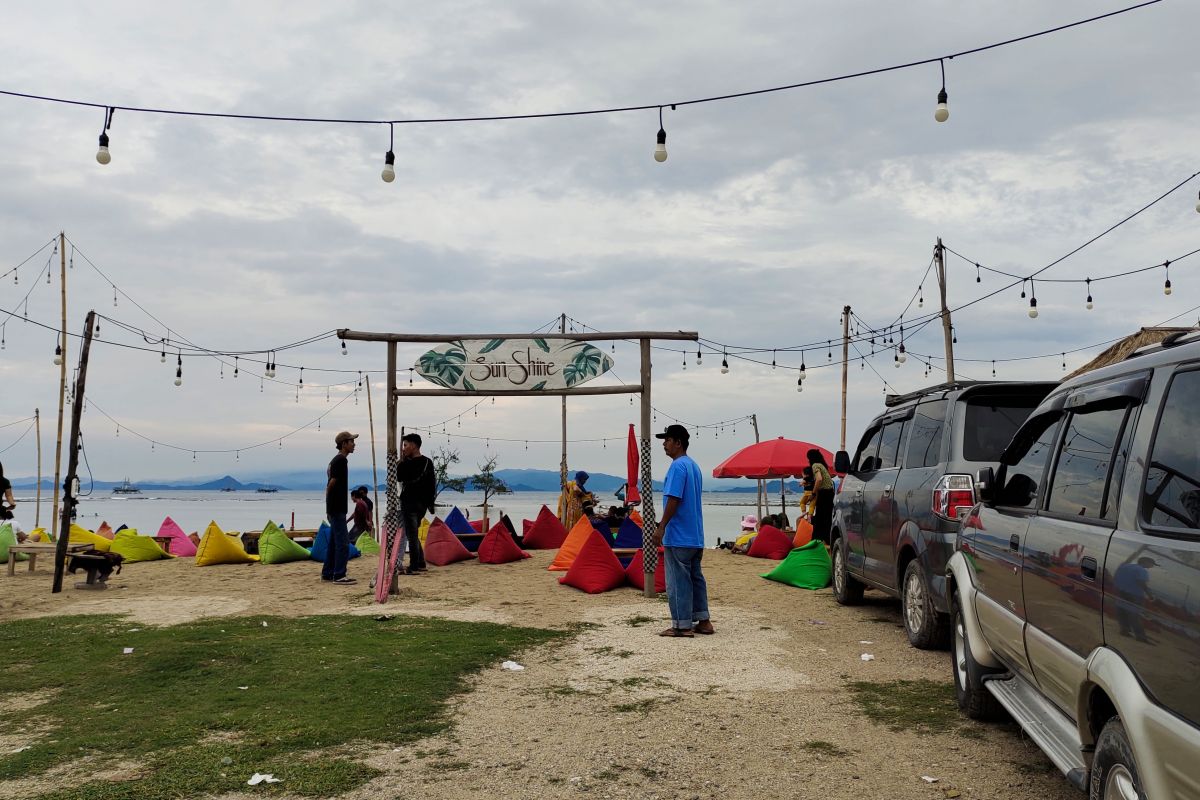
<box><xmin>1046</xmin><ymin>405</ymin><xmax>1129</xmax><ymax>519</ymax></box>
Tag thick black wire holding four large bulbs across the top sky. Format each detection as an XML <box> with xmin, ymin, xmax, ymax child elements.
<box><xmin>0</xmin><ymin>0</ymin><xmax>1162</xmax><ymax>127</ymax></box>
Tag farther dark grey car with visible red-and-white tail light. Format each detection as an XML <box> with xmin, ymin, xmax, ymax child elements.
<box><xmin>829</xmin><ymin>381</ymin><xmax>1057</xmax><ymax>649</ymax></box>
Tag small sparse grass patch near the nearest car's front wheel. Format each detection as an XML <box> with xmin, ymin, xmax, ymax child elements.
<box><xmin>848</xmin><ymin>680</ymin><xmax>964</xmax><ymax>734</ymax></box>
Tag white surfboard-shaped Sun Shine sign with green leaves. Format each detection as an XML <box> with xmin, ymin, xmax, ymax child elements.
<box><xmin>413</xmin><ymin>337</ymin><xmax>613</xmax><ymax>392</ymax></box>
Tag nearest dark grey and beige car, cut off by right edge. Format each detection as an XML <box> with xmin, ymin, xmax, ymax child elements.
<box><xmin>947</xmin><ymin>331</ymin><xmax>1200</xmax><ymax>800</ymax></box>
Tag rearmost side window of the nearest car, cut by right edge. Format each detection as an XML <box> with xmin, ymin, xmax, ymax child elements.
<box><xmin>1142</xmin><ymin>371</ymin><xmax>1200</xmax><ymax>534</ymax></box>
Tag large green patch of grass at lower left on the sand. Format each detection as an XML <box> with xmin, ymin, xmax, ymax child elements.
<box><xmin>0</xmin><ymin>616</ymin><xmax>562</xmax><ymax>800</ymax></box>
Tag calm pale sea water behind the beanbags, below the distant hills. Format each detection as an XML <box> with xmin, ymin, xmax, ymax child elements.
<box><xmin>16</xmin><ymin>489</ymin><xmax>796</xmax><ymax>547</ymax></box>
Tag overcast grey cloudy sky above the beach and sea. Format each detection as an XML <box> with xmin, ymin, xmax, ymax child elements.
<box><xmin>0</xmin><ymin>0</ymin><xmax>1200</xmax><ymax>480</ymax></box>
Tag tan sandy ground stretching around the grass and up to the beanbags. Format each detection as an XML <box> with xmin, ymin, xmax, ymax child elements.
<box><xmin>0</xmin><ymin>551</ymin><xmax>1079</xmax><ymax>800</ymax></box>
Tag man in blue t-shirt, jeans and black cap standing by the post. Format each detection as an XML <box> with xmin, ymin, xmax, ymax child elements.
<box><xmin>654</xmin><ymin>425</ymin><xmax>714</xmax><ymax>638</ymax></box>
